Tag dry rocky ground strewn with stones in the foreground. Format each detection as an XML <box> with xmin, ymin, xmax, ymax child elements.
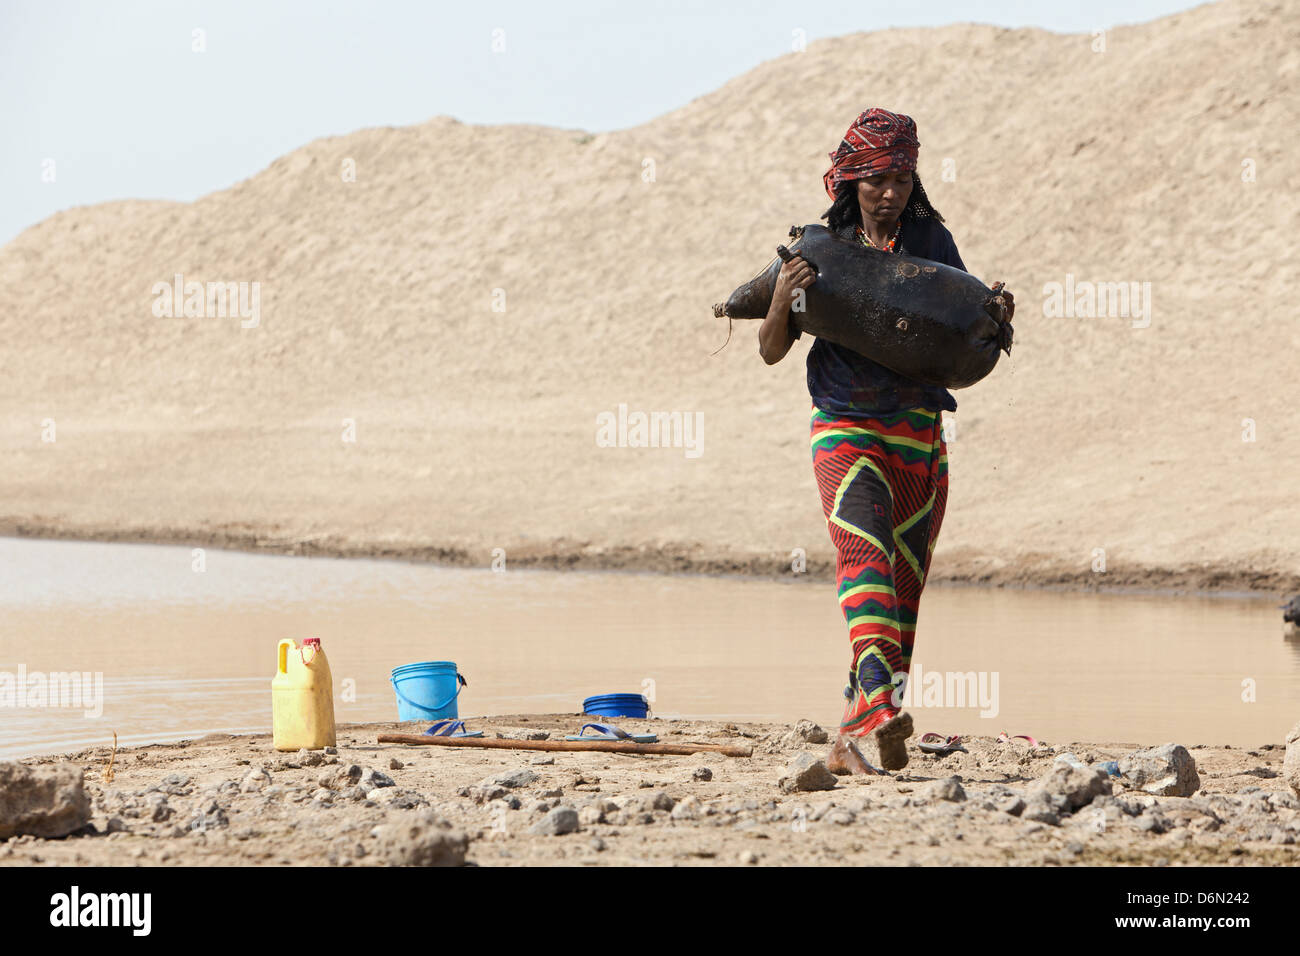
<box><xmin>0</xmin><ymin>714</ymin><xmax>1300</xmax><ymax>866</ymax></box>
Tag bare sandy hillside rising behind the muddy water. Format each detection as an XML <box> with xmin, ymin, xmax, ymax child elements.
<box><xmin>0</xmin><ymin>0</ymin><xmax>1300</xmax><ymax>588</ymax></box>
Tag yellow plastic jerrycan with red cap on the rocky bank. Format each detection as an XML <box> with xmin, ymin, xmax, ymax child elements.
<box><xmin>270</xmin><ymin>637</ymin><xmax>335</xmax><ymax>750</ymax></box>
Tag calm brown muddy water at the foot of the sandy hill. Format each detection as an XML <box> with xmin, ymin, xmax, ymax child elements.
<box><xmin>0</xmin><ymin>538</ymin><xmax>1300</xmax><ymax>757</ymax></box>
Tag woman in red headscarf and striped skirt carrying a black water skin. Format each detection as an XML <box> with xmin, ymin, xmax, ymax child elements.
<box><xmin>758</xmin><ymin>109</ymin><xmax>1014</xmax><ymax>774</ymax></box>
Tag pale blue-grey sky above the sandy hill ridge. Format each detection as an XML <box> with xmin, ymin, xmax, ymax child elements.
<box><xmin>0</xmin><ymin>0</ymin><xmax>1197</xmax><ymax>243</ymax></box>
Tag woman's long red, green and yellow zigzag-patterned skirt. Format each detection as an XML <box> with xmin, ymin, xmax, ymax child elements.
<box><xmin>813</xmin><ymin>407</ymin><xmax>948</xmax><ymax>736</ymax></box>
